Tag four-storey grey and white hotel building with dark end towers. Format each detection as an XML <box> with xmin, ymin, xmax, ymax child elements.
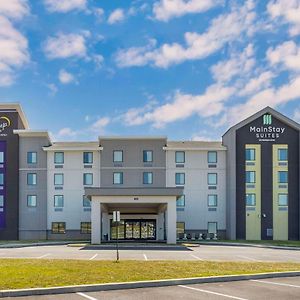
<box><xmin>0</xmin><ymin>103</ymin><xmax>300</xmax><ymax>244</ymax></box>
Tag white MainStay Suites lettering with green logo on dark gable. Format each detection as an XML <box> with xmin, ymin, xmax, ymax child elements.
<box><xmin>249</xmin><ymin>114</ymin><xmax>286</xmax><ymax>142</ymax></box>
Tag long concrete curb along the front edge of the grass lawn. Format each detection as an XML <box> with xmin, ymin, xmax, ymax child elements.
<box><xmin>0</xmin><ymin>271</ymin><xmax>300</xmax><ymax>298</ymax></box>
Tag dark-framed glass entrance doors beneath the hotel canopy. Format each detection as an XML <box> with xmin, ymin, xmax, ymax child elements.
<box><xmin>110</xmin><ymin>220</ymin><xmax>156</xmax><ymax>240</ymax></box>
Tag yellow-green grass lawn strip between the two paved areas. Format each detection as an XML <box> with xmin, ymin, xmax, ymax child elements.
<box><xmin>0</xmin><ymin>259</ymin><xmax>300</xmax><ymax>290</ymax></box>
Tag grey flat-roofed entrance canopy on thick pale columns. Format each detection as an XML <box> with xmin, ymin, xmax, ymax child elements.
<box><xmin>85</xmin><ymin>187</ymin><xmax>183</xmax><ymax>244</ymax></box>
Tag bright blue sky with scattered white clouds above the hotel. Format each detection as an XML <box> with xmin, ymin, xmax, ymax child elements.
<box><xmin>0</xmin><ymin>0</ymin><xmax>300</xmax><ymax>141</ymax></box>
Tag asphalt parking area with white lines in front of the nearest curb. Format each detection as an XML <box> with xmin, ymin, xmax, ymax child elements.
<box><xmin>7</xmin><ymin>277</ymin><xmax>300</xmax><ymax>300</ymax></box>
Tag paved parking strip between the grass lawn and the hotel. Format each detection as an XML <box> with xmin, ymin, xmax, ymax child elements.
<box><xmin>0</xmin><ymin>245</ymin><xmax>300</xmax><ymax>263</ymax></box>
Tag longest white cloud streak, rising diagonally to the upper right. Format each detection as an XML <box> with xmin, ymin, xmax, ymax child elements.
<box><xmin>115</xmin><ymin>0</ymin><xmax>256</xmax><ymax>68</ymax></box>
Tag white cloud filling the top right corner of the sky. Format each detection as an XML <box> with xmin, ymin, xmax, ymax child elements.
<box><xmin>267</xmin><ymin>0</ymin><xmax>300</xmax><ymax>36</ymax></box>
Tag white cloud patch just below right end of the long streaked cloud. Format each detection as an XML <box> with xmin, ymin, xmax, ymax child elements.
<box><xmin>211</xmin><ymin>44</ymin><xmax>255</xmax><ymax>82</ymax></box>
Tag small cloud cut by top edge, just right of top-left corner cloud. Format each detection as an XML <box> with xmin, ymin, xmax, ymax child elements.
<box><xmin>44</xmin><ymin>0</ymin><xmax>87</xmax><ymax>13</ymax></box>
